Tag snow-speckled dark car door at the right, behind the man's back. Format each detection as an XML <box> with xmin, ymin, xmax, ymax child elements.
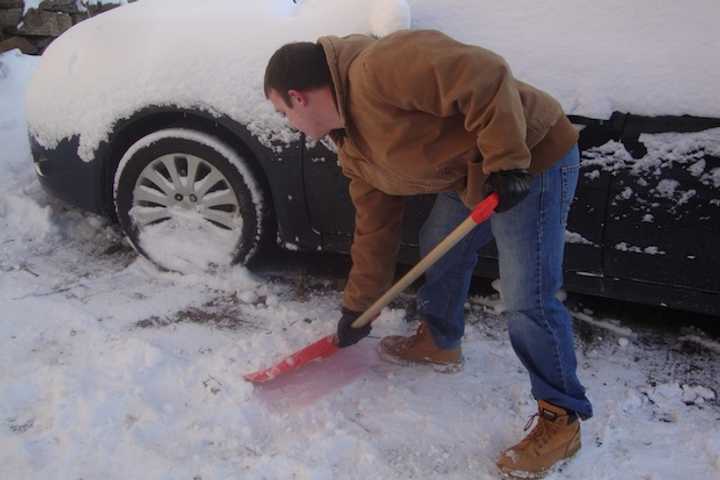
<box><xmin>604</xmin><ymin>115</ymin><xmax>720</xmax><ymax>304</ymax></box>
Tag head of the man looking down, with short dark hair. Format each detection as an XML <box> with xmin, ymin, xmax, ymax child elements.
<box><xmin>264</xmin><ymin>42</ymin><xmax>343</xmax><ymax>138</ymax></box>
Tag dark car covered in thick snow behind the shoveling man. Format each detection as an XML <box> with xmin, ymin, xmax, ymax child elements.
<box><xmin>26</xmin><ymin>0</ymin><xmax>720</xmax><ymax>315</ymax></box>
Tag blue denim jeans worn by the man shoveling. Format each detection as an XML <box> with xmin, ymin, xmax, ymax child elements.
<box><xmin>417</xmin><ymin>146</ymin><xmax>592</xmax><ymax>418</ymax></box>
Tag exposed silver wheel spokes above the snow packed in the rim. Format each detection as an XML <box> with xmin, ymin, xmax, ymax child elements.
<box><xmin>132</xmin><ymin>153</ymin><xmax>242</xmax><ymax>231</ymax></box>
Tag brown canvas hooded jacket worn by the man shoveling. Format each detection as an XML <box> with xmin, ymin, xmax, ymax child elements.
<box><xmin>318</xmin><ymin>30</ymin><xmax>577</xmax><ymax>312</ymax></box>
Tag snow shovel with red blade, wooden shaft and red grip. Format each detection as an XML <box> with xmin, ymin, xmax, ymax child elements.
<box><xmin>244</xmin><ymin>193</ymin><xmax>499</xmax><ymax>383</ymax></box>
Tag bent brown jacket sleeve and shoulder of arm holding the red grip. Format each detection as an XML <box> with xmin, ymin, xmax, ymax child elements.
<box><xmin>363</xmin><ymin>32</ymin><xmax>530</xmax><ymax>174</ymax></box>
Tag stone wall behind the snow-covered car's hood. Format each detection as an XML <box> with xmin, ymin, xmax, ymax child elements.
<box><xmin>0</xmin><ymin>0</ymin><xmax>129</xmax><ymax>55</ymax></box>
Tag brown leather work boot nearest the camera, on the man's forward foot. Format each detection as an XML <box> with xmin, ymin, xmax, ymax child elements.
<box><xmin>497</xmin><ymin>400</ymin><xmax>580</xmax><ymax>479</ymax></box>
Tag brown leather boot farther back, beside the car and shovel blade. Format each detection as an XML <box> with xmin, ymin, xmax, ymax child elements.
<box><xmin>380</xmin><ymin>321</ymin><xmax>462</xmax><ymax>372</ymax></box>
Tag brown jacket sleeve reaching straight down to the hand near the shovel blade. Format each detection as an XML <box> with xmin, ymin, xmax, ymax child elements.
<box><xmin>343</xmin><ymin>164</ymin><xmax>404</xmax><ymax>312</ymax></box>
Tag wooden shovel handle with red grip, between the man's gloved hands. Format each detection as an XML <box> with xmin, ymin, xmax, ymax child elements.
<box><xmin>352</xmin><ymin>193</ymin><xmax>499</xmax><ymax>328</ymax></box>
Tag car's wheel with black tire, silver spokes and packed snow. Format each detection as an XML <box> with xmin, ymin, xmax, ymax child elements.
<box><xmin>113</xmin><ymin>128</ymin><xmax>267</xmax><ymax>273</ymax></box>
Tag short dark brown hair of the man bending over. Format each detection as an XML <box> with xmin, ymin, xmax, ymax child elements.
<box><xmin>264</xmin><ymin>42</ymin><xmax>332</xmax><ymax>105</ymax></box>
